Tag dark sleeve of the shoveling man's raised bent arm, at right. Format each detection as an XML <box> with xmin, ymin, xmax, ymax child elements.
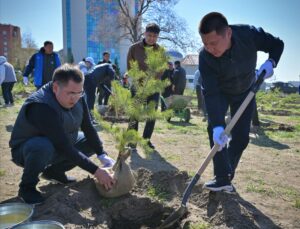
<box><xmin>250</xmin><ymin>26</ymin><xmax>284</xmax><ymax>66</ymax></box>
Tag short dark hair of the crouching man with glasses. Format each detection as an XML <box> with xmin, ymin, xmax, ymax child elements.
<box><xmin>52</xmin><ymin>64</ymin><xmax>84</xmax><ymax>85</ymax></box>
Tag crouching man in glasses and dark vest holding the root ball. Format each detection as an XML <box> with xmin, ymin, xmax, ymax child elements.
<box><xmin>9</xmin><ymin>64</ymin><xmax>115</xmax><ymax>204</ymax></box>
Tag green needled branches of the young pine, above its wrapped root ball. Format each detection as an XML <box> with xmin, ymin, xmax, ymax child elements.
<box><xmin>95</xmin><ymin>47</ymin><xmax>171</xmax><ymax>154</ymax></box>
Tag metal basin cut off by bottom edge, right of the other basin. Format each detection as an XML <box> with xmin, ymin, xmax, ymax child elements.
<box><xmin>13</xmin><ymin>220</ymin><xmax>65</xmax><ymax>229</ymax></box>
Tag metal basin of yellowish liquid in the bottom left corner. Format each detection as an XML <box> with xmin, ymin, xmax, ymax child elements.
<box><xmin>0</xmin><ymin>203</ymin><xmax>33</xmax><ymax>229</ymax></box>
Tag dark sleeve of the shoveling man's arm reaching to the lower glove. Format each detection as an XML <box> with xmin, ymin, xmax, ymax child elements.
<box><xmin>199</xmin><ymin>52</ymin><xmax>224</xmax><ymax>128</ymax></box>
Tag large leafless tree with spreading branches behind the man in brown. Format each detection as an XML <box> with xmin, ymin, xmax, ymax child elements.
<box><xmin>88</xmin><ymin>0</ymin><xmax>200</xmax><ymax>52</ymax></box>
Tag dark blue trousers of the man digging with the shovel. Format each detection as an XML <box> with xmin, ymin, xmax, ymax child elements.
<box><xmin>207</xmin><ymin>92</ymin><xmax>255</xmax><ymax>180</ymax></box>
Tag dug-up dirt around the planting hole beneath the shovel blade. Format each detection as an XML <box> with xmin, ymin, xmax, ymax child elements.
<box><xmin>29</xmin><ymin>169</ymin><xmax>277</xmax><ymax>229</ymax></box>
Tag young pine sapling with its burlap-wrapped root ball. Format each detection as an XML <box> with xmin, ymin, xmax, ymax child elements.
<box><xmin>94</xmin><ymin>47</ymin><xmax>169</xmax><ymax>197</ymax></box>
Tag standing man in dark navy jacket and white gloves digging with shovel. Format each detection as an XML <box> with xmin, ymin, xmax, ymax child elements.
<box><xmin>199</xmin><ymin>12</ymin><xmax>284</xmax><ymax>192</ymax></box>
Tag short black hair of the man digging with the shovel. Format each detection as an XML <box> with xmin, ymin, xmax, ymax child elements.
<box><xmin>199</xmin><ymin>12</ymin><xmax>228</xmax><ymax>35</ymax></box>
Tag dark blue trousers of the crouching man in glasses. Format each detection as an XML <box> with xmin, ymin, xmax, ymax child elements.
<box><xmin>12</xmin><ymin>132</ymin><xmax>95</xmax><ymax>187</ymax></box>
